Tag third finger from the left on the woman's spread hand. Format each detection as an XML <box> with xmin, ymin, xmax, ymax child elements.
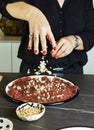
<box><xmin>40</xmin><ymin>35</ymin><xmax>47</xmax><ymax>55</ymax></box>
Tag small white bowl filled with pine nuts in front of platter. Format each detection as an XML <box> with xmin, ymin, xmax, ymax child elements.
<box><xmin>16</xmin><ymin>102</ymin><xmax>45</xmax><ymax>121</ymax></box>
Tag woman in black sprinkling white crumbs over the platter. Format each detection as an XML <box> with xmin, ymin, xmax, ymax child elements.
<box><xmin>0</xmin><ymin>0</ymin><xmax>94</xmax><ymax>74</ymax></box>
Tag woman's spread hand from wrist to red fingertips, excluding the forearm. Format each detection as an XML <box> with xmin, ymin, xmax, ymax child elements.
<box><xmin>28</xmin><ymin>7</ymin><xmax>56</xmax><ymax>55</ymax></box>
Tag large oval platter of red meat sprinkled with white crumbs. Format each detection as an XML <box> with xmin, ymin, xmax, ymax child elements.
<box><xmin>6</xmin><ymin>75</ymin><xmax>79</xmax><ymax>104</ymax></box>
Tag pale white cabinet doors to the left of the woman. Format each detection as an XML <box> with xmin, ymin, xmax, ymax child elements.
<box><xmin>0</xmin><ymin>41</ymin><xmax>21</xmax><ymax>72</ymax></box>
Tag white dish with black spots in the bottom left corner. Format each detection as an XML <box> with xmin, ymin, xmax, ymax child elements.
<box><xmin>0</xmin><ymin>117</ymin><xmax>13</xmax><ymax>130</ymax></box>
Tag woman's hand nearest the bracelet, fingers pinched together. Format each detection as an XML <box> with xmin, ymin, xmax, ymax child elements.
<box><xmin>51</xmin><ymin>36</ymin><xmax>75</xmax><ymax>59</ymax></box>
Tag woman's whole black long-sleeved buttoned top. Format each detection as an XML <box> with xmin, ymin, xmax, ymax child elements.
<box><xmin>0</xmin><ymin>0</ymin><xmax>94</xmax><ymax>67</ymax></box>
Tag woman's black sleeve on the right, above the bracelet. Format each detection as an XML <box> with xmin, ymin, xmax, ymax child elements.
<box><xmin>79</xmin><ymin>0</ymin><xmax>94</xmax><ymax>51</ymax></box>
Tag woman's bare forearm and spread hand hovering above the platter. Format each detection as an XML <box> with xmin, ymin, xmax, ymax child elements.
<box><xmin>6</xmin><ymin>1</ymin><xmax>56</xmax><ymax>55</ymax></box>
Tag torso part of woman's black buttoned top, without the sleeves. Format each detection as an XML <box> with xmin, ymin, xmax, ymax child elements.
<box><xmin>18</xmin><ymin>0</ymin><xmax>90</xmax><ymax>67</ymax></box>
